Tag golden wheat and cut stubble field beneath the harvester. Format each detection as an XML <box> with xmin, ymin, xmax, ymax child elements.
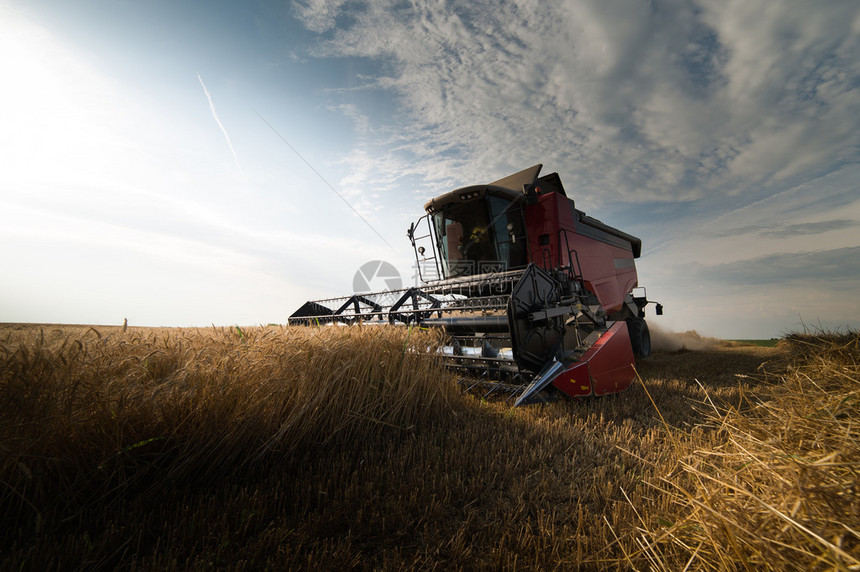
<box><xmin>0</xmin><ymin>324</ymin><xmax>860</xmax><ymax>570</ymax></box>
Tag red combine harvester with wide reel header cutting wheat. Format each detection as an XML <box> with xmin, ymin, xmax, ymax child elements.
<box><xmin>289</xmin><ymin>165</ymin><xmax>663</xmax><ymax>405</ymax></box>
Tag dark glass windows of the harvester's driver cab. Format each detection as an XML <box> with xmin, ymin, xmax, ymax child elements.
<box><xmin>433</xmin><ymin>194</ymin><xmax>526</xmax><ymax>278</ymax></box>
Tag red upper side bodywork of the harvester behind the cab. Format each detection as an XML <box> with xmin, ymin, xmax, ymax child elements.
<box><xmin>525</xmin><ymin>192</ymin><xmax>638</xmax><ymax>314</ymax></box>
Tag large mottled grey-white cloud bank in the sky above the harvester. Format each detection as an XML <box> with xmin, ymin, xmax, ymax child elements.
<box><xmin>296</xmin><ymin>0</ymin><xmax>860</xmax><ymax>206</ymax></box>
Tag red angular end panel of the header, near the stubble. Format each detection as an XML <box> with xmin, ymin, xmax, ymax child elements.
<box><xmin>552</xmin><ymin>322</ymin><xmax>636</xmax><ymax>397</ymax></box>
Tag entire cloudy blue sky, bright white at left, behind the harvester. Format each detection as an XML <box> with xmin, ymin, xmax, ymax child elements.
<box><xmin>0</xmin><ymin>0</ymin><xmax>860</xmax><ymax>338</ymax></box>
